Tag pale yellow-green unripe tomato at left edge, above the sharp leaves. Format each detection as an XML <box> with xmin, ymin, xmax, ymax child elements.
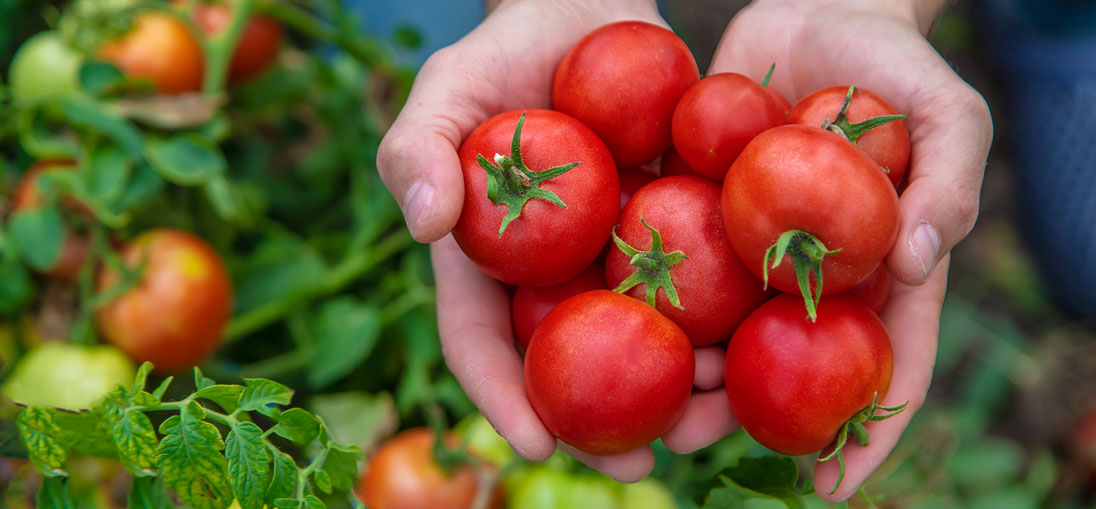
<box><xmin>0</xmin><ymin>341</ymin><xmax>135</xmax><ymax>410</ymax></box>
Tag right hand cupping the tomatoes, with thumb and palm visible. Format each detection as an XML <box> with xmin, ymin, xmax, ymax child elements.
<box><xmin>692</xmin><ymin>0</ymin><xmax>993</xmax><ymax>501</ymax></box>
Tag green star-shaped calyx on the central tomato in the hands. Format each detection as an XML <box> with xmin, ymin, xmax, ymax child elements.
<box><xmin>612</xmin><ymin>216</ymin><xmax>688</xmax><ymax>309</ymax></box>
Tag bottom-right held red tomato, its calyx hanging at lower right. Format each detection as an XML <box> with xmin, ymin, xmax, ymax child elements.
<box><xmin>724</xmin><ymin>294</ymin><xmax>894</xmax><ymax>455</ymax></box>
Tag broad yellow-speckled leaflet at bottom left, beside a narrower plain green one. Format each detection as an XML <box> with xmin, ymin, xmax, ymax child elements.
<box><xmin>157</xmin><ymin>401</ymin><xmax>233</xmax><ymax>509</ymax></box>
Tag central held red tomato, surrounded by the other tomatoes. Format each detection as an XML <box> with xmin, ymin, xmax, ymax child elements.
<box><xmin>605</xmin><ymin>177</ymin><xmax>767</xmax><ymax>347</ymax></box>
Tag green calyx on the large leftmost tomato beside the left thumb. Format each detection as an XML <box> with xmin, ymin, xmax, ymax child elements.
<box><xmin>476</xmin><ymin>113</ymin><xmax>582</xmax><ymax>238</ymax></box>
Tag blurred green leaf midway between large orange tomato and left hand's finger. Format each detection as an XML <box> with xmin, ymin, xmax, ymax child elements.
<box><xmin>308</xmin><ymin>297</ymin><xmax>380</xmax><ymax>388</ymax></box>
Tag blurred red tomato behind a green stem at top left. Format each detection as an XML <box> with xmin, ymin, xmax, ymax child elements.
<box><xmin>194</xmin><ymin>2</ymin><xmax>282</xmax><ymax>81</ymax></box>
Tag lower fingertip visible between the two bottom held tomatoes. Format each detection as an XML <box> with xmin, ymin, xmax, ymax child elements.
<box><xmin>662</xmin><ymin>388</ymin><xmax>739</xmax><ymax>454</ymax></box>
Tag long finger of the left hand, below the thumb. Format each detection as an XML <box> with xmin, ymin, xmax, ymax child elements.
<box><xmin>431</xmin><ymin>236</ymin><xmax>556</xmax><ymax>461</ymax></box>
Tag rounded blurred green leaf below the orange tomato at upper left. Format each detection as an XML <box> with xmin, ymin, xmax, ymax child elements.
<box><xmin>145</xmin><ymin>133</ymin><xmax>227</xmax><ymax>185</ymax></box>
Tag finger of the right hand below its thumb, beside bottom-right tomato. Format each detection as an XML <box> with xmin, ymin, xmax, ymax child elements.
<box><xmin>814</xmin><ymin>257</ymin><xmax>948</xmax><ymax>502</ymax></box>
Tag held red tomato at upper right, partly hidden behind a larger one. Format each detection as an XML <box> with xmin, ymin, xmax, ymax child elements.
<box><xmin>788</xmin><ymin>86</ymin><xmax>910</xmax><ymax>188</ymax></box>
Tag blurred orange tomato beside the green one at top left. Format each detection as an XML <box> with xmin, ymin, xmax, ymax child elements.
<box><xmin>96</xmin><ymin>11</ymin><xmax>205</xmax><ymax>94</ymax></box>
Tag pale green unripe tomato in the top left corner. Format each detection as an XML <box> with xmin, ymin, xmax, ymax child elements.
<box><xmin>8</xmin><ymin>31</ymin><xmax>83</xmax><ymax>103</ymax></box>
